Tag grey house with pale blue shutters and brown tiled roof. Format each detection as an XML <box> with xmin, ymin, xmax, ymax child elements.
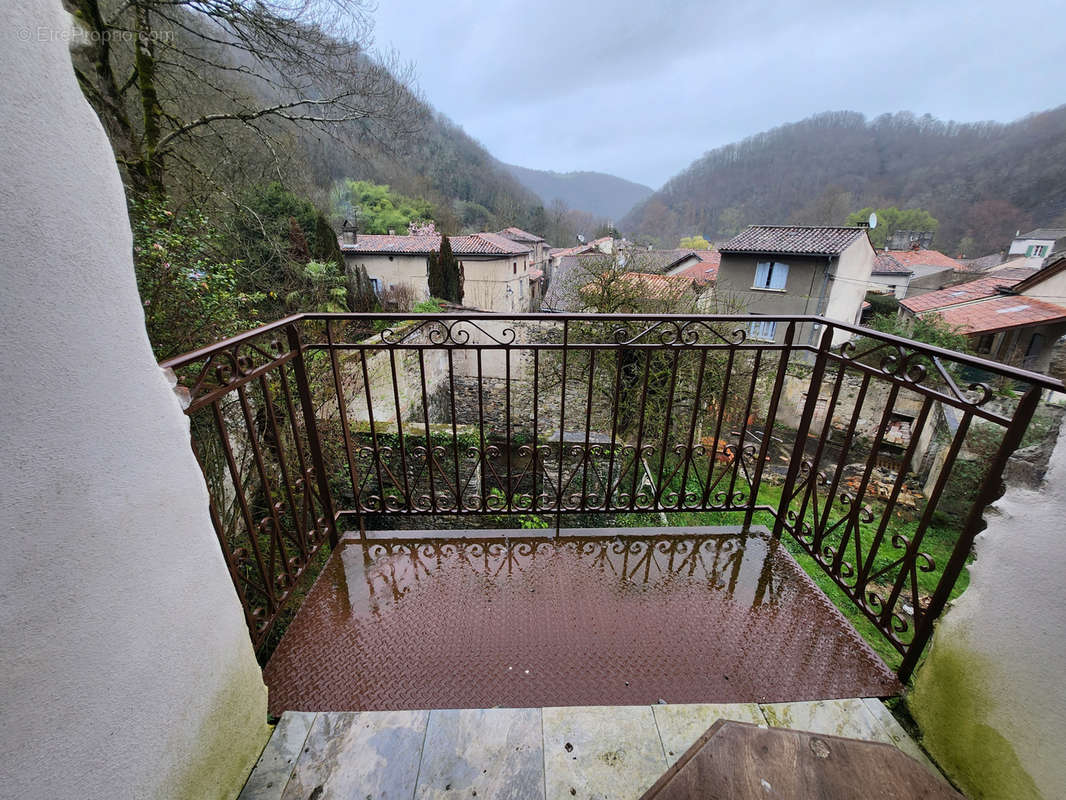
<box><xmin>715</xmin><ymin>225</ymin><xmax>876</xmax><ymax>343</ymax></box>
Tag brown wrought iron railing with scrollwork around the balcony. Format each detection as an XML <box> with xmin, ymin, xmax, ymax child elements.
<box><xmin>162</xmin><ymin>314</ymin><xmax>1062</xmax><ymax>679</ymax></box>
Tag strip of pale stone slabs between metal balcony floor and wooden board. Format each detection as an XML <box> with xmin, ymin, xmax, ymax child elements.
<box><xmin>240</xmin><ymin>698</ymin><xmax>939</xmax><ymax>800</ymax></box>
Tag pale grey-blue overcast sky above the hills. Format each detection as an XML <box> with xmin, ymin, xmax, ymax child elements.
<box><xmin>374</xmin><ymin>0</ymin><xmax>1066</xmax><ymax>188</ymax></box>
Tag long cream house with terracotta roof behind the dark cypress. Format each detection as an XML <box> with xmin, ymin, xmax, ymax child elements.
<box><xmin>340</xmin><ymin>227</ymin><xmax>532</xmax><ymax>313</ymax></box>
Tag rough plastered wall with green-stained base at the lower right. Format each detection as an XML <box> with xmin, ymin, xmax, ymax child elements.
<box><xmin>909</xmin><ymin>422</ymin><xmax>1066</xmax><ymax>800</ymax></box>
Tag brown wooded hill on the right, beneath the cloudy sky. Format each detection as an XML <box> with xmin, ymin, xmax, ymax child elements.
<box><xmin>619</xmin><ymin>106</ymin><xmax>1066</xmax><ymax>256</ymax></box>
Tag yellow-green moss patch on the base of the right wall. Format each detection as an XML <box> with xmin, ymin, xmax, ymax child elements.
<box><xmin>907</xmin><ymin>635</ymin><xmax>1044</xmax><ymax>800</ymax></box>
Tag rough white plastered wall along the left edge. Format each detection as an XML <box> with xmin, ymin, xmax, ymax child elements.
<box><xmin>0</xmin><ymin>0</ymin><xmax>269</xmax><ymax>800</ymax></box>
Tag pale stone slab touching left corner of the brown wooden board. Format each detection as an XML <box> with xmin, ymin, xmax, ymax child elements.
<box><xmin>544</xmin><ymin>706</ymin><xmax>667</xmax><ymax>800</ymax></box>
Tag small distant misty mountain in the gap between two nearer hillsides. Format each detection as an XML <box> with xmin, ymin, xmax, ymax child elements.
<box><xmin>503</xmin><ymin>164</ymin><xmax>655</xmax><ymax>221</ymax></box>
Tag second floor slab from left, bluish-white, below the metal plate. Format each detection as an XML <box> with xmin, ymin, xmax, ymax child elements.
<box><xmin>282</xmin><ymin>711</ymin><xmax>430</xmax><ymax>800</ymax></box>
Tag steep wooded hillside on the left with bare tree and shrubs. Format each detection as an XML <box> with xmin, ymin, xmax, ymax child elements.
<box><xmin>71</xmin><ymin>0</ymin><xmax>541</xmax><ymax>358</ymax></box>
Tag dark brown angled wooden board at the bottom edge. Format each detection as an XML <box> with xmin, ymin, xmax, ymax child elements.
<box><xmin>642</xmin><ymin>720</ymin><xmax>963</xmax><ymax>800</ymax></box>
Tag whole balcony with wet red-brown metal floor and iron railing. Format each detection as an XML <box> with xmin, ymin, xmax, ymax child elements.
<box><xmin>163</xmin><ymin>314</ymin><xmax>1061</xmax><ymax>714</ymax></box>
